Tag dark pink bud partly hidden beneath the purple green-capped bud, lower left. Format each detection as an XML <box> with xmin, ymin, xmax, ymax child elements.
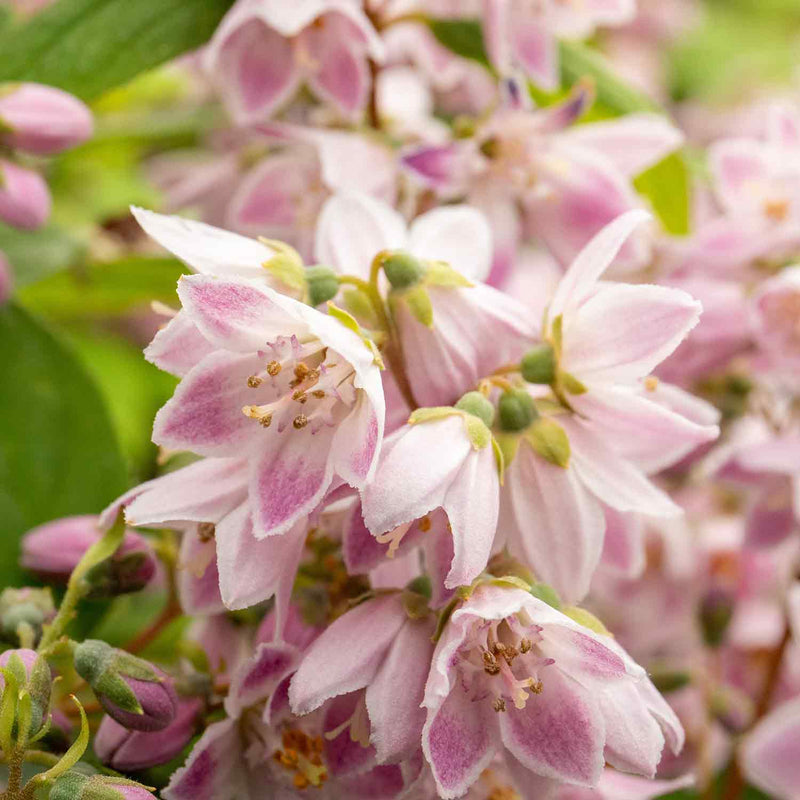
<box><xmin>94</xmin><ymin>697</ymin><xmax>203</xmax><ymax>772</ymax></box>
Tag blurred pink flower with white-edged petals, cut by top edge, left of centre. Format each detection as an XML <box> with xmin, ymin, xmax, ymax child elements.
<box><xmin>204</xmin><ymin>0</ymin><xmax>383</xmax><ymax>124</ymax></box>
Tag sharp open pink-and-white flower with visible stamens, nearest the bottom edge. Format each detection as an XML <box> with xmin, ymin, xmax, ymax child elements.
<box><xmin>422</xmin><ymin>584</ymin><xmax>683</xmax><ymax>798</ymax></box>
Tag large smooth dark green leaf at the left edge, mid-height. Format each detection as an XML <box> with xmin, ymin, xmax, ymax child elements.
<box><xmin>0</xmin><ymin>303</ymin><xmax>127</xmax><ymax>585</ymax></box>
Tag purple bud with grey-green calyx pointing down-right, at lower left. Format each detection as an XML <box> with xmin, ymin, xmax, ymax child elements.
<box><xmin>75</xmin><ymin>639</ymin><xmax>178</xmax><ymax>731</ymax></box>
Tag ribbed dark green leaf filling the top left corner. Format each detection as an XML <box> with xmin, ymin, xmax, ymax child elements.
<box><xmin>0</xmin><ymin>0</ymin><xmax>232</xmax><ymax>100</ymax></box>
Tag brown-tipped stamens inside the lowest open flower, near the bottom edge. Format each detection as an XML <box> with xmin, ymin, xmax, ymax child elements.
<box><xmin>460</xmin><ymin>612</ymin><xmax>553</xmax><ymax>712</ymax></box>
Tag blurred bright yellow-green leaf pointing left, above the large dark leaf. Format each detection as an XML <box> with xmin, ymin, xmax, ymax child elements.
<box><xmin>19</xmin><ymin>256</ymin><xmax>186</xmax><ymax>321</ymax></box>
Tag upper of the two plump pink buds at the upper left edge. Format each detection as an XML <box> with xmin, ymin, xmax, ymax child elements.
<box><xmin>0</xmin><ymin>83</ymin><xmax>94</xmax><ymax>155</ymax></box>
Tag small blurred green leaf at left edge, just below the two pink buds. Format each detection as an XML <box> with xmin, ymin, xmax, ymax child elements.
<box><xmin>0</xmin><ymin>223</ymin><xmax>86</xmax><ymax>287</ymax></box>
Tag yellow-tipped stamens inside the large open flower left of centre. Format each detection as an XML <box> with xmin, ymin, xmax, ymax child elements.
<box><xmin>242</xmin><ymin>336</ymin><xmax>356</xmax><ymax>434</ymax></box>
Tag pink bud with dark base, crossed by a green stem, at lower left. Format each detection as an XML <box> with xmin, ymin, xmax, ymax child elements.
<box><xmin>20</xmin><ymin>515</ymin><xmax>156</xmax><ymax>597</ymax></box>
